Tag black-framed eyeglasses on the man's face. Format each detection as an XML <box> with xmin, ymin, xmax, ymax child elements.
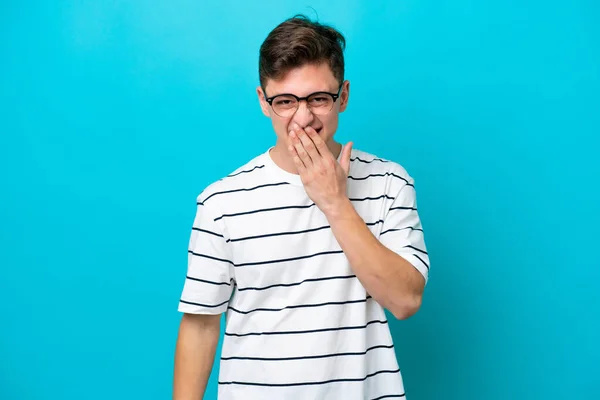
<box><xmin>263</xmin><ymin>84</ymin><xmax>343</xmax><ymax>118</ymax></box>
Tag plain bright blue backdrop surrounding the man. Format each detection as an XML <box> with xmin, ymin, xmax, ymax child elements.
<box><xmin>0</xmin><ymin>0</ymin><xmax>600</xmax><ymax>400</ymax></box>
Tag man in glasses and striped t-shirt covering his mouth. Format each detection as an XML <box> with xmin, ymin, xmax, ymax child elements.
<box><xmin>174</xmin><ymin>16</ymin><xmax>429</xmax><ymax>400</ymax></box>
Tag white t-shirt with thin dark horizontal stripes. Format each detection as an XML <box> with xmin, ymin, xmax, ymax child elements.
<box><xmin>179</xmin><ymin>149</ymin><xmax>429</xmax><ymax>400</ymax></box>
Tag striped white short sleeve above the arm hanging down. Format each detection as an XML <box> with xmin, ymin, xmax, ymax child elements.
<box><xmin>178</xmin><ymin>197</ymin><xmax>234</xmax><ymax>314</ymax></box>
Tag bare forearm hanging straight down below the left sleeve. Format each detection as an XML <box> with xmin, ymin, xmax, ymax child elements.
<box><xmin>173</xmin><ymin>314</ymin><xmax>220</xmax><ymax>400</ymax></box>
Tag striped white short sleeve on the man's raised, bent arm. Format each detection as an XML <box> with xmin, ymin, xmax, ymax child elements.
<box><xmin>379</xmin><ymin>175</ymin><xmax>429</xmax><ymax>284</ymax></box>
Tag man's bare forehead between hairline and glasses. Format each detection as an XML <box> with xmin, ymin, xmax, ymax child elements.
<box><xmin>265</xmin><ymin>63</ymin><xmax>338</xmax><ymax>96</ymax></box>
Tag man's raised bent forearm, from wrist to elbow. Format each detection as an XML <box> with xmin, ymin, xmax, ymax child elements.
<box><xmin>327</xmin><ymin>201</ymin><xmax>425</xmax><ymax>319</ymax></box>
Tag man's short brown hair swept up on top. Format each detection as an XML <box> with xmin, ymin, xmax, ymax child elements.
<box><xmin>258</xmin><ymin>14</ymin><xmax>346</xmax><ymax>90</ymax></box>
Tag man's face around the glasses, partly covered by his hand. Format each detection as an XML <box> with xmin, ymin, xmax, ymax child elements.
<box><xmin>257</xmin><ymin>63</ymin><xmax>350</xmax><ymax>153</ymax></box>
